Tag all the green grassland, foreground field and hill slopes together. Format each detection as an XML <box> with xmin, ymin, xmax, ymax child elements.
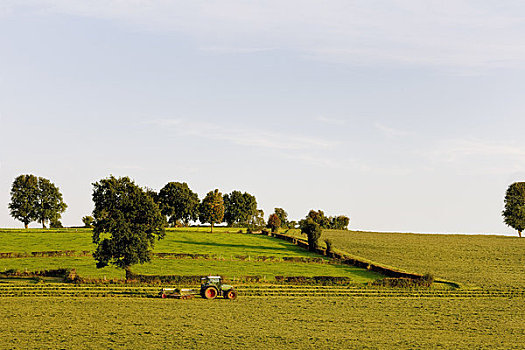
<box><xmin>0</xmin><ymin>228</ymin><xmax>525</xmax><ymax>349</ymax></box>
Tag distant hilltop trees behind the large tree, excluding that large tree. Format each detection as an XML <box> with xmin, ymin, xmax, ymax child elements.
<box><xmin>9</xmin><ymin>175</ymin><xmax>350</xmax><ymax>232</ymax></box>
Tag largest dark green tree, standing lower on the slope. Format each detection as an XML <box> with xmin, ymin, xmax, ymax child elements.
<box><xmin>93</xmin><ymin>176</ymin><xmax>166</xmax><ymax>270</ymax></box>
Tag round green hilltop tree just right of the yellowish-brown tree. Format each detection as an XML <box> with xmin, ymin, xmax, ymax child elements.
<box><xmin>223</xmin><ymin>191</ymin><xmax>257</xmax><ymax>226</ymax></box>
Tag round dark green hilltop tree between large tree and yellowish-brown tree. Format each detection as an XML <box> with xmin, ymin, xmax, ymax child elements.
<box><xmin>158</xmin><ymin>182</ymin><xmax>199</xmax><ymax>226</ymax></box>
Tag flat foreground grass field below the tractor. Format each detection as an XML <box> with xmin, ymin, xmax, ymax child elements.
<box><xmin>0</xmin><ymin>297</ymin><xmax>525</xmax><ymax>349</ymax></box>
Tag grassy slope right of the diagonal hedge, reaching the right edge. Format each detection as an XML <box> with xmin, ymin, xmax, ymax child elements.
<box><xmin>316</xmin><ymin>230</ymin><xmax>525</xmax><ymax>288</ymax></box>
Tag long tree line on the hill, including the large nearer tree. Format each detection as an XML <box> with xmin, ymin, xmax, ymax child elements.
<box><xmin>9</xmin><ymin>175</ymin><xmax>349</xmax><ymax>269</ymax></box>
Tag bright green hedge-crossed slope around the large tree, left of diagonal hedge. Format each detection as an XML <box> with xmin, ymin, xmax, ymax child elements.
<box><xmin>0</xmin><ymin>229</ymin><xmax>381</xmax><ymax>283</ymax></box>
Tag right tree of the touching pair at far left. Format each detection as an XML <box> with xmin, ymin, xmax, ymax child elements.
<box><xmin>36</xmin><ymin>177</ymin><xmax>67</xmax><ymax>228</ymax></box>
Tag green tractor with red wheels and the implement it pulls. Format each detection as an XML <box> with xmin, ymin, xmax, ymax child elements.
<box><xmin>159</xmin><ymin>276</ymin><xmax>237</xmax><ymax>300</ymax></box>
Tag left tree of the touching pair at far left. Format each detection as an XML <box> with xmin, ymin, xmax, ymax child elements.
<box><xmin>9</xmin><ymin>175</ymin><xmax>38</xmax><ymax>229</ymax></box>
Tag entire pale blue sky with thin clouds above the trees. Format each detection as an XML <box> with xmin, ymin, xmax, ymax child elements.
<box><xmin>0</xmin><ymin>0</ymin><xmax>525</xmax><ymax>234</ymax></box>
